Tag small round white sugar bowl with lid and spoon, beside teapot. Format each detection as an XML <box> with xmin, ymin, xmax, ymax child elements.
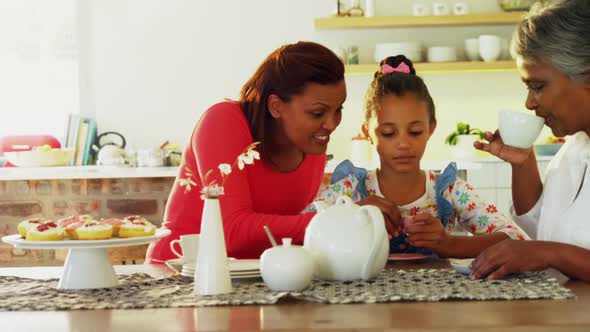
<box><xmin>260</xmin><ymin>238</ymin><xmax>315</xmax><ymax>291</ymax></box>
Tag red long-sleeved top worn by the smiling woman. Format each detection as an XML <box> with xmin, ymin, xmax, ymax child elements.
<box><xmin>148</xmin><ymin>101</ymin><xmax>326</xmax><ymax>262</ymax></box>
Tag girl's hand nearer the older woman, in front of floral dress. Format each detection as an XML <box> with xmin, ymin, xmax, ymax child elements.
<box><xmin>405</xmin><ymin>213</ymin><xmax>451</xmax><ymax>252</ymax></box>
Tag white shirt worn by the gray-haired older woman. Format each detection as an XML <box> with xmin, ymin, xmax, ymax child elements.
<box><xmin>511</xmin><ymin>132</ymin><xmax>590</xmax><ymax>249</ymax></box>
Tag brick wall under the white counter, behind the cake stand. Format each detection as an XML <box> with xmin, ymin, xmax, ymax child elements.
<box><xmin>0</xmin><ymin>177</ymin><xmax>174</xmax><ymax>266</ymax></box>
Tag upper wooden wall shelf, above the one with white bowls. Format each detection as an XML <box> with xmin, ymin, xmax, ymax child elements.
<box><xmin>315</xmin><ymin>12</ymin><xmax>524</xmax><ymax>30</ymax></box>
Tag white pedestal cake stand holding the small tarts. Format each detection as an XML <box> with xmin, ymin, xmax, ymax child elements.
<box><xmin>2</xmin><ymin>229</ymin><xmax>171</xmax><ymax>289</ymax></box>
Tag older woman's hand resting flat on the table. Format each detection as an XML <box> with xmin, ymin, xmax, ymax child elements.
<box><xmin>471</xmin><ymin>240</ymin><xmax>554</xmax><ymax>280</ymax></box>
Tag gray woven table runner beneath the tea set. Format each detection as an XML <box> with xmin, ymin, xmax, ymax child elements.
<box><xmin>0</xmin><ymin>269</ymin><xmax>575</xmax><ymax>311</ymax></box>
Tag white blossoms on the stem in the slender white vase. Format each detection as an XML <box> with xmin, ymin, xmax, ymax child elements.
<box><xmin>178</xmin><ymin>142</ymin><xmax>260</xmax><ymax>199</ymax></box>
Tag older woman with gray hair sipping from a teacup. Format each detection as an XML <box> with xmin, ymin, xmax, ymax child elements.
<box><xmin>471</xmin><ymin>0</ymin><xmax>590</xmax><ymax>281</ymax></box>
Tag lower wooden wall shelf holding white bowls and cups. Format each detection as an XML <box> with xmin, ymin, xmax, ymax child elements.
<box><xmin>345</xmin><ymin>60</ymin><xmax>516</xmax><ymax>75</ymax></box>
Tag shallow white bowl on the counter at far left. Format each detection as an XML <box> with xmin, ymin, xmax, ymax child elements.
<box><xmin>4</xmin><ymin>149</ymin><xmax>75</xmax><ymax>167</ymax></box>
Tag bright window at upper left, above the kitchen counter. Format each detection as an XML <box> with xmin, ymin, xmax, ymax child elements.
<box><xmin>0</xmin><ymin>0</ymin><xmax>79</xmax><ymax>142</ymax></box>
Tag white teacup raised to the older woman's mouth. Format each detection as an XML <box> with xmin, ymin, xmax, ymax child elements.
<box><xmin>498</xmin><ymin>111</ymin><xmax>545</xmax><ymax>149</ymax></box>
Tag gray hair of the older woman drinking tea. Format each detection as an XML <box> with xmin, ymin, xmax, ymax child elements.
<box><xmin>510</xmin><ymin>0</ymin><xmax>590</xmax><ymax>80</ymax></box>
